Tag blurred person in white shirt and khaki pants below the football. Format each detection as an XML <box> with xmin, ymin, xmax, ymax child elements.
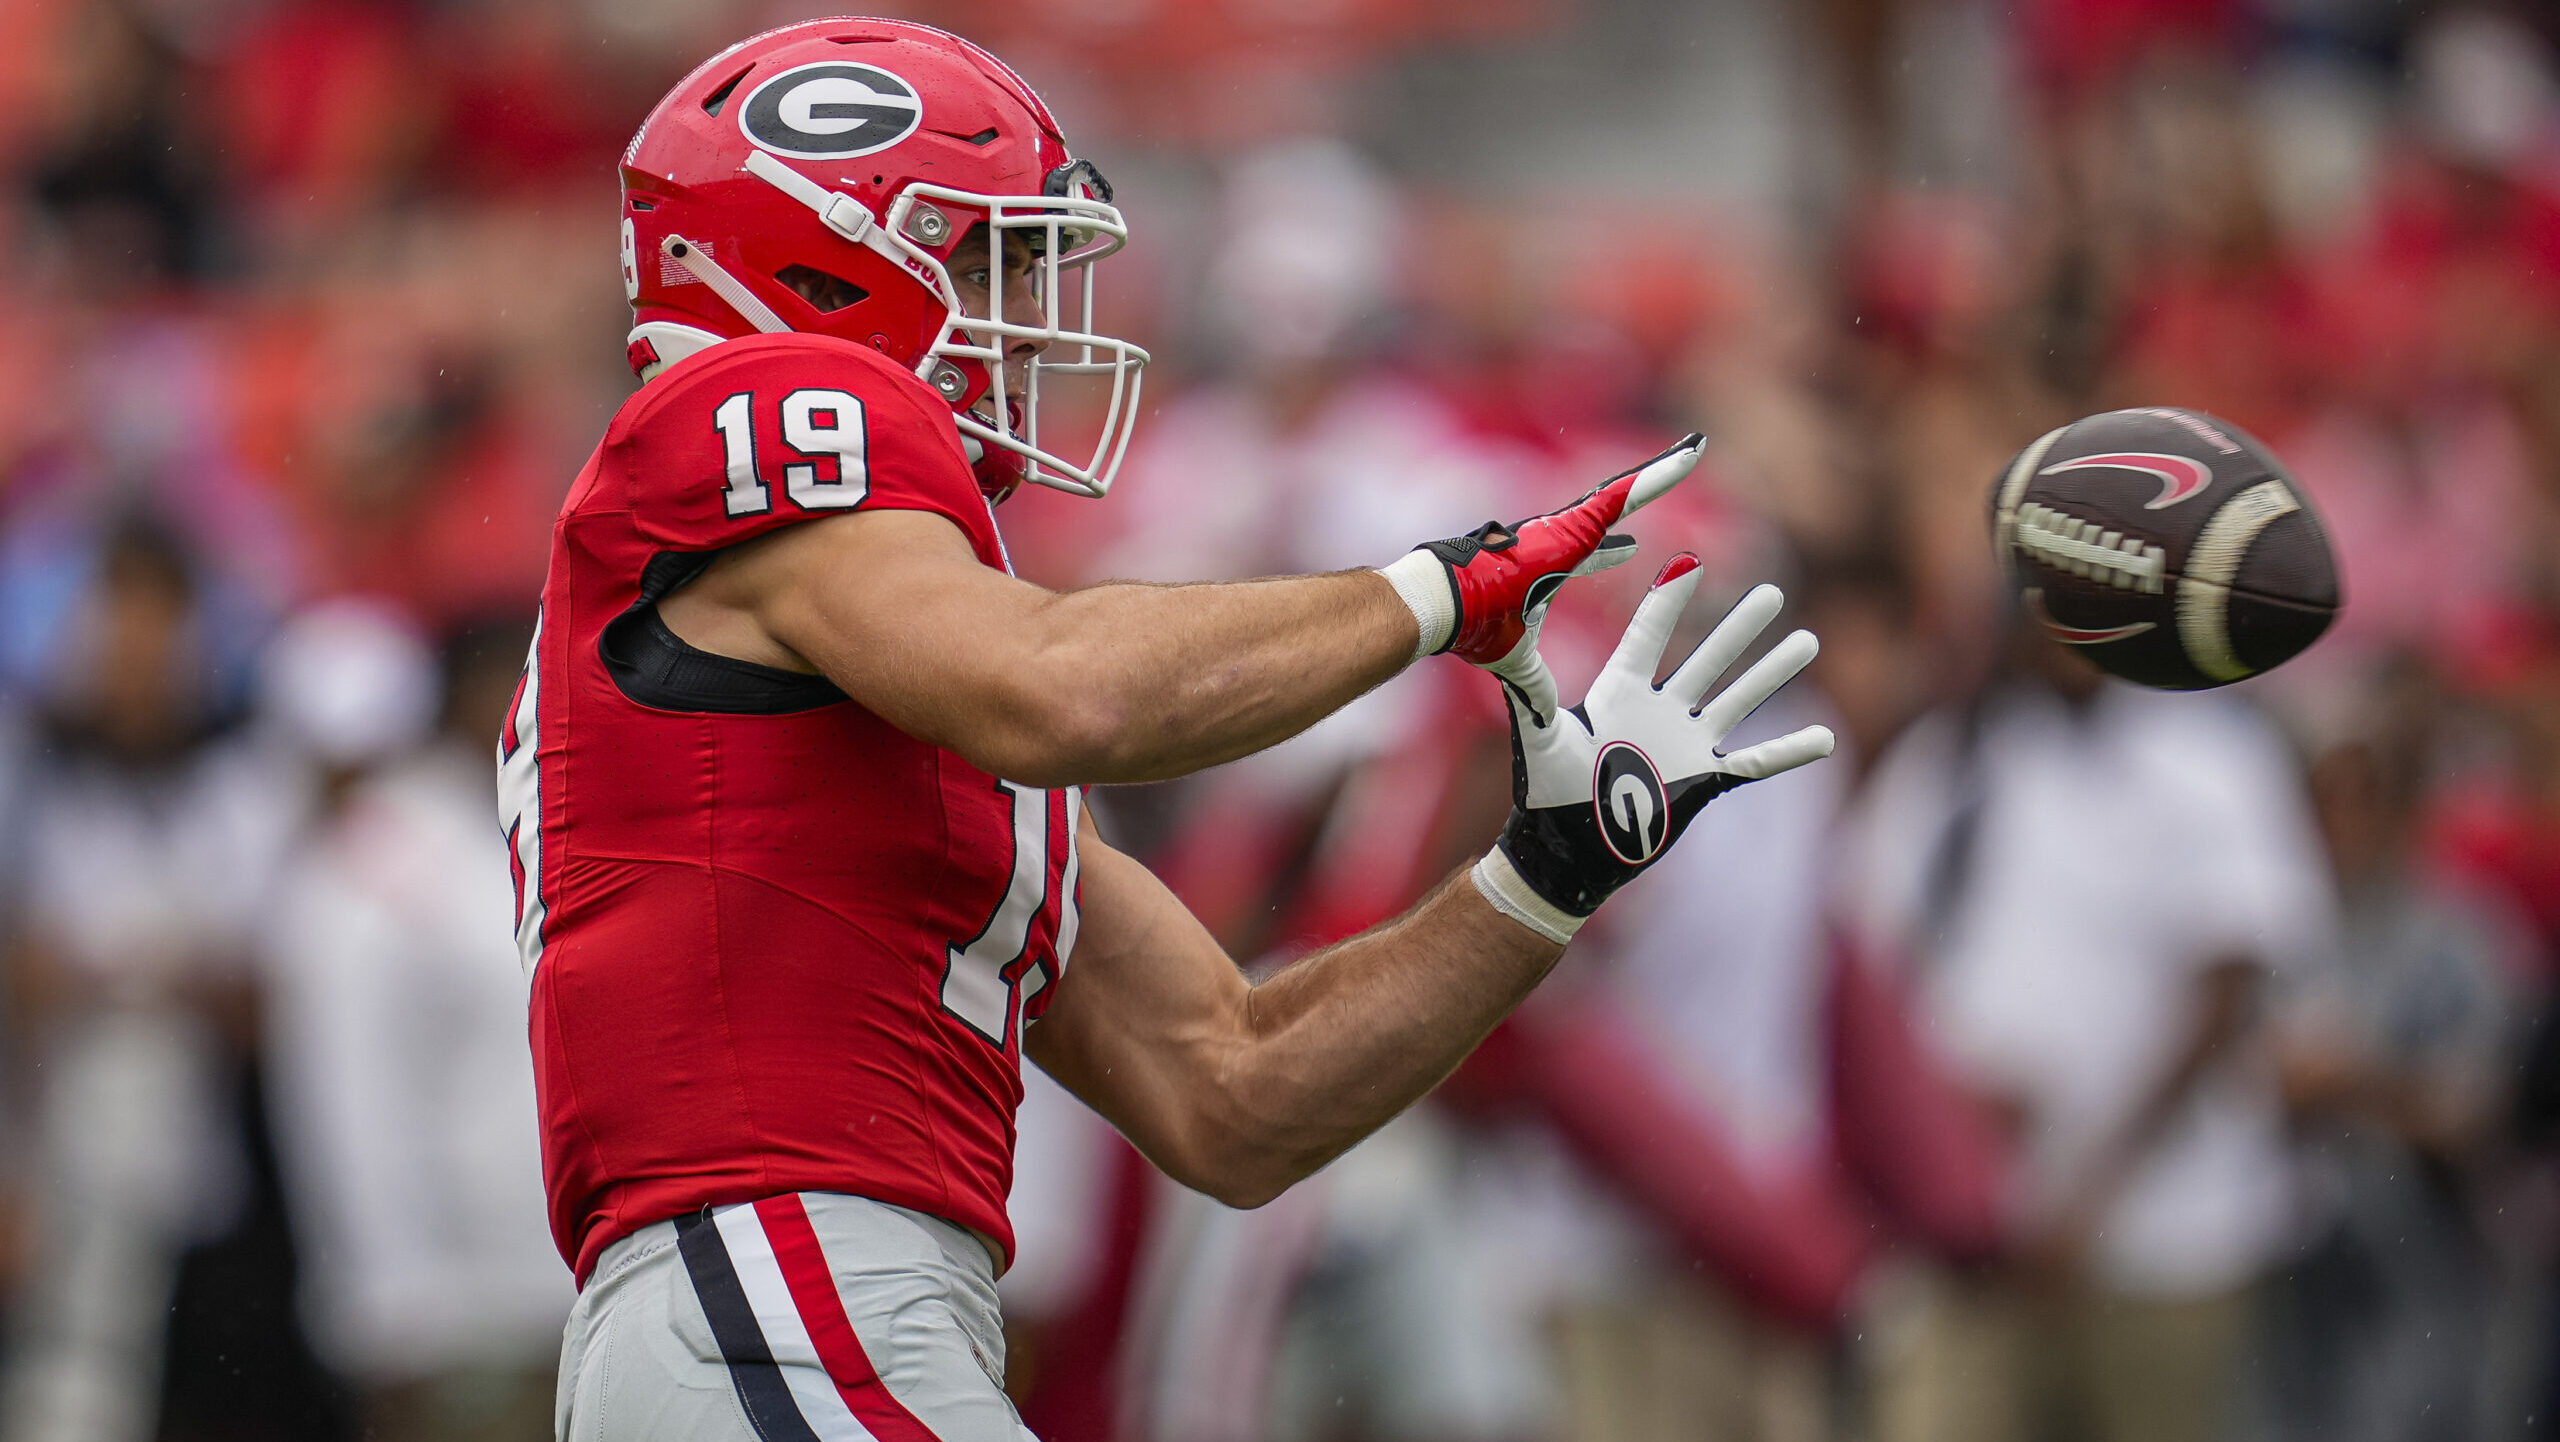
<box><xmin>1851</xmin><ymin>617</ymin><xmax>2337</xmax><ymax>1442</ymax></box>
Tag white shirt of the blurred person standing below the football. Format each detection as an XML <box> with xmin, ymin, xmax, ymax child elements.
<box><xmin>1846</xmin><ymin>684</ymin><xmax>2337</xmax><ymax>1299</ymax></box>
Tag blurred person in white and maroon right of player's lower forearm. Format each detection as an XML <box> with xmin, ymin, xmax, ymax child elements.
<box><xmin>1510</xmin><ymin>556</ymin><xmax>2002</xmax><ymax>1442</ymax></box>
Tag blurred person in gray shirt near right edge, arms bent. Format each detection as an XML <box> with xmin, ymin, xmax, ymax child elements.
<box><xmin>2266</xmin><ymin>671</ymin><xmax>2522</xmax><ymax>1439</ymax></box>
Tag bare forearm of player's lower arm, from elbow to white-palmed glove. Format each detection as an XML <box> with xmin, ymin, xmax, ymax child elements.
<box><xmin>1193</xmin><ymin>873</ymin><xmax>1564</xmax><ymax>1206</ymax></box>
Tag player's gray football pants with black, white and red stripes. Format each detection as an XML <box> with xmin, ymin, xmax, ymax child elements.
<box><xmin>558</xmin><ymin>1191</ymin><xmax>1034</xmax><ymax>1442</ymax></box>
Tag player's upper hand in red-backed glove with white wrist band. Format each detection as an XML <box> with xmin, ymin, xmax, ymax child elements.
<box><xmin>1382</xmin><ymin>433</ymin><xmax>1708</xmax><ymax>715</ymax></box>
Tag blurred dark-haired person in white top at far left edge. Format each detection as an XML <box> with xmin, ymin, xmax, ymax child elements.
<box><xmin>0</xmin><ymin>523</ymin><xmax>307</xmax><ymax>1442</ymax></box>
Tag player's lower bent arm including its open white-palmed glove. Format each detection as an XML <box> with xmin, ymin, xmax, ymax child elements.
<box><xmin>1024</xmin><ymin>556</ymin><xmax>1830</xmax><ymax>1206</ymax></box>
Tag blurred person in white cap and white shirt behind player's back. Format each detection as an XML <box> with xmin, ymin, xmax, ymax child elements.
<box><xmin>264</xmin><ymin>602</ymin><xmax>573</xmax><ymax>1442</ymax></box>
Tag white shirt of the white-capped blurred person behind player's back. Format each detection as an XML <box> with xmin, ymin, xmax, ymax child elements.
<box><xmin>266</xmin><ymin>745</ymin><xmax>573</xmax><ymax>1383</ymax></box>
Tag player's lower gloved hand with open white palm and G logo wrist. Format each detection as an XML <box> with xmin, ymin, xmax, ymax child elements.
<box><xmin>1475</xmin><ymin>553</ymin><xmax>1830</xmax><ymax>943</ymax></box>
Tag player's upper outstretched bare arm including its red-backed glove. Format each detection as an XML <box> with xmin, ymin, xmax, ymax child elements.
<box><xmin>660</xmin><ymin>435</ymin><xmax>1700</xmax><ymax>786</ymax></box>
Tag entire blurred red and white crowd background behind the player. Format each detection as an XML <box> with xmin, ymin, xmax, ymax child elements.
<box><xmin>0</xmin><ymin>0</ymin><xmax>2560</xmax><ymax>1442</ymax></box>
